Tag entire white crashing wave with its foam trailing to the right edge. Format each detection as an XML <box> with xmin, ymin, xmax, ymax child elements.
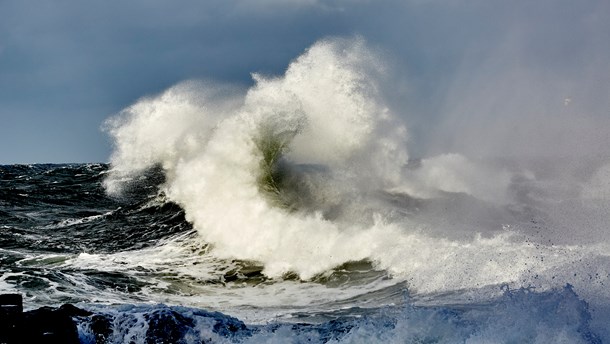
<box><xmin>106</xmin><ymin>39</ymin><xmax>607</xmax><ymax>306</ymax></box>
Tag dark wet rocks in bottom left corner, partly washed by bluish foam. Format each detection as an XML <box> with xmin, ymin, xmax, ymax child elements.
<box><xmin>0</xmin><ymin>294</ymin><xmax>250</xmax><ymax>344</ymax></box>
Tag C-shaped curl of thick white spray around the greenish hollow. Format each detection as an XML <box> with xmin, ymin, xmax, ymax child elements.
<box><xmin>107</xmin><ymin>40</ymin><xmax>407</xmax><ymax>278</ymax></box>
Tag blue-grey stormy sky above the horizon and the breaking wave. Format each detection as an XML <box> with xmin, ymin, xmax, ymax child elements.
<box><xmin>0</xmin><ymin>0</ymin><xmax>610</xmax><ymax>164</ymax></box>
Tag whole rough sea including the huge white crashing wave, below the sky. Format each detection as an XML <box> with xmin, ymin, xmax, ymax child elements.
<box><xmin>0</xmin><ymin>40</ymin><xmax>610</xmax><ymax>343</ymax></box>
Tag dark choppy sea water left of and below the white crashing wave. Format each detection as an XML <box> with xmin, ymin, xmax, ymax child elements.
<box><xmin>0</xmin><ymin>164</ymin><xmax>607</xmax><ymax>343</ymax></box>
